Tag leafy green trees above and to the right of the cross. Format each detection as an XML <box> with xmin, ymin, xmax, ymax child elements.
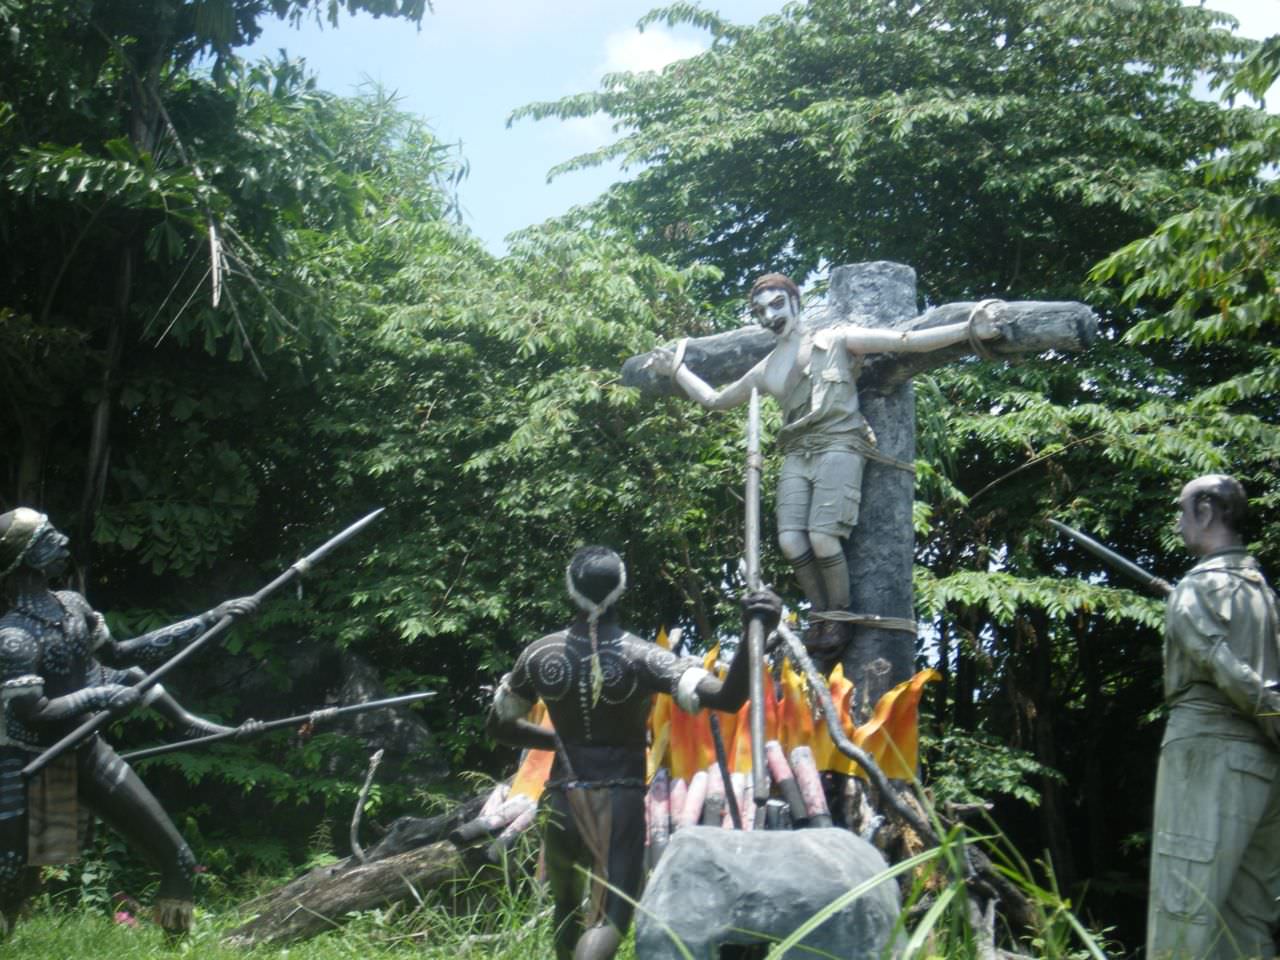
<box><xmin>512</xmin><ymin>0</ymin><xmax>1280</xmax><ymax>936</ymax></box>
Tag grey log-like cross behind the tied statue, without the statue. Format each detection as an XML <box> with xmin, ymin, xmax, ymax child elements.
<box><xmin>622</xmin><ymin>261</ymin><xmax>1098</xmax><ymax>721</ymax></box>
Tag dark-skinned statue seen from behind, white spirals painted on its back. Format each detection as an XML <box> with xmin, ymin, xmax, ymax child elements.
<box><xmin>489</xmin><ymin>547</ymin><xmax>781</xmax><ymax>960</ymax></box>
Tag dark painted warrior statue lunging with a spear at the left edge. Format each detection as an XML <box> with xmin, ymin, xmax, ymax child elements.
<box><xmin>0</xmin><ymin>507</ymin><xmax>257</xmax><ymax>936</ymax></box>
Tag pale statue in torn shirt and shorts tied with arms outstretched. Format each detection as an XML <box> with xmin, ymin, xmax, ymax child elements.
<box><xmin>652</xmin><ymin>273</ymin><xmax>1001</xmax><ymax>666</ymax></box>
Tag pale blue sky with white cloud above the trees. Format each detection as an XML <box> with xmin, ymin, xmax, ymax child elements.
<box><xmin>242</xmin><ymin>0</ymin><xmax>1280</xmax><ymax>253</ymax></box>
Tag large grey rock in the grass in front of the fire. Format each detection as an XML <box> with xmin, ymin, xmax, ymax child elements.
<box><xmin>636</xmin><ymin>827</ymin><xmax>900</xmax><ymax>960</ymax></box>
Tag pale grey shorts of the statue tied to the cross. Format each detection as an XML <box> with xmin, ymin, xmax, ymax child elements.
<box><xmin>777</xmin><ymin>451</ymin><xmax>867</xmax><ymax>540</ymax></box>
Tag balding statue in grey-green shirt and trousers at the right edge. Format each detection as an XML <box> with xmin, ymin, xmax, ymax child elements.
<box><xmin>1147</xmin><ymin>475</ymin><xmax>1280</xmax><ymax>960</ymax></box>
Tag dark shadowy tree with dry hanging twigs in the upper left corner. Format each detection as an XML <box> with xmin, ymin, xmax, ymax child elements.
<box><xmin>0</xmin><ymin>0</ymin><xmax>425</xmax><ymax>580</ymax></box>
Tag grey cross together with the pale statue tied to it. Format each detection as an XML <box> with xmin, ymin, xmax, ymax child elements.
<box><xmin>622</xmin><ymin>261</ymin><xmax>1097</xmax><ymax>721</ymax></box>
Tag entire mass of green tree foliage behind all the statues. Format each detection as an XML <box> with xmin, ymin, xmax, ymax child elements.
<box><xmin>0</xmin><ymin>0</ymin><xmax>1280</xmax><ymax>956</ymax></box>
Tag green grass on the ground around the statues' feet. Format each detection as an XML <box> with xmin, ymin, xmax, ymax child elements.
<box><xmin>0</xmin><ymin>824</ymin><xmax>1115</xmax><ymax>960</ymax></box>
